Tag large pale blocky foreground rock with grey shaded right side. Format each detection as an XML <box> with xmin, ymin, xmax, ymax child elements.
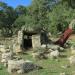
<box><xmin>8</xmin><ymin>59</ymin><xmax>42</xmax><ymax>74</ymax></box>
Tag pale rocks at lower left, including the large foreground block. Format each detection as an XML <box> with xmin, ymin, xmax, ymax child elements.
<box><xmin>1</xmin><ymin>46</ymin><xmax>41</xmax><ymax>74</ymax></box>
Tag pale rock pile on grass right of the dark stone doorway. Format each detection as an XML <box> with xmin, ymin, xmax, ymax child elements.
<box><xmin>32</xmin><ymin>44</ymin><xmax>64</xmax><ymax>59</ymax></box>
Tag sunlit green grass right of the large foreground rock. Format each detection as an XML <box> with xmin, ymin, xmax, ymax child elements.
<box><xmin>16</xmin><ymin>49</ymin><xmax>75</xmax><ymax>75</ymax></box>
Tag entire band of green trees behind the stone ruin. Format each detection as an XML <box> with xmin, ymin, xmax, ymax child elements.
<box><xmin>0</xmin><ymin>0</ymin><xmax>75</xmax><ymax>35</ymax></box>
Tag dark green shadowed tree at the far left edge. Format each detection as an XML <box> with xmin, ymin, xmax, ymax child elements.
<box><xmin>0</xmin><ymin>2</ymin><xmax>17</xmax><ymax>36</ymax></box>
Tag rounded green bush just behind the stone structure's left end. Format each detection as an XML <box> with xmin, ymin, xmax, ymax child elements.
<box><xmin>14</xmin><ymin>15</ymin><xmax>34</xmax><ymax>29</ymax></box>
